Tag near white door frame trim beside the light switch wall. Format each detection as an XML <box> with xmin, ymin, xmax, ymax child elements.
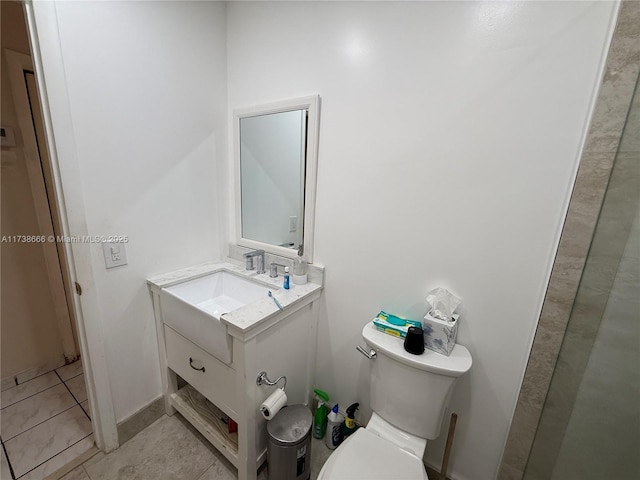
<box><xmin>23</xmin><ymin>0</ymin><xmax>118</xmax><ymax>452</ymax></box>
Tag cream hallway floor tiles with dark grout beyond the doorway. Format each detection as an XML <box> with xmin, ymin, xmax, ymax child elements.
<box><xmin>0</xmin><ymin>360</ymin><xmax>93</xmax><ymax>480</ymax></box>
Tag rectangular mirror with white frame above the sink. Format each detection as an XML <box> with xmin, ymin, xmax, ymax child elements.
<box><xmin>234</xmin><ymin>95</ymin><xmax>320</xmax><ymax>262</ymax></box>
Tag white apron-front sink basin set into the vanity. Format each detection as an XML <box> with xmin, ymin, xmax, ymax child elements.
<box><xmin>160</xmin><ymin>270</ymin><xmax>273</xmax><ymax>363</ymax></box>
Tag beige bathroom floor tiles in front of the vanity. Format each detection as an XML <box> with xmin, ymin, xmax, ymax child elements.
<box><xmin>54</xmin><ymin>413</ymin><xmax>331</xmax><ymax>480</ymax></box>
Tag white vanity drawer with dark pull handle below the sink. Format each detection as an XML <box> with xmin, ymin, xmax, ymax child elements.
<box><xmin>164</xmin><ymin>325</ymin><xmax>237</xmax><ymax>418</ymax></box>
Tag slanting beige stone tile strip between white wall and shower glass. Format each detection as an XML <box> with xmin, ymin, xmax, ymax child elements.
<box><xmin>498</xmin><ymin>0</ymin><xmax>640</xmax><ymax>480</ymax></box>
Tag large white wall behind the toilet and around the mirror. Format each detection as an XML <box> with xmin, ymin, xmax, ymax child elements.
<box><xmin>227</xmin><ymin>2</ymin><xmax>616</xmax><ymax>480</ymax></box>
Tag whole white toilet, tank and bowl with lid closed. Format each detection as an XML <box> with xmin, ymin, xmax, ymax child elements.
<box><xmin>318</xmin><ymin>323</ymin><xmax>471</xmax><ymax>480</ymax></box>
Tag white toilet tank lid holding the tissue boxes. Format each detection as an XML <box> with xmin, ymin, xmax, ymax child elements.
<box><xmin>362</xmin><ymin>322</ymin><xmax>472</xmax><ymax>377</ymax></box>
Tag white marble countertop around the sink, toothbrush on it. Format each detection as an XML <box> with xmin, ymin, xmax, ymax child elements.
<box><xmin>147</xmin><ymin>261</ymin><xmax>322</xmax><ymax>334</ymax></box>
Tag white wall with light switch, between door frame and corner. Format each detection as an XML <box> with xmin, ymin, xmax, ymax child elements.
<box><xmin>34</xmin><ymin>2</ymin><xmax>227</xmax><ymax>421</ymax></box>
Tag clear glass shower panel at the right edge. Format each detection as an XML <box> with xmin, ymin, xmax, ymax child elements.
<box><xmin>524</xmin><ymin>77</ymin><xmax>640</xmax><ymax>480</ymax></box>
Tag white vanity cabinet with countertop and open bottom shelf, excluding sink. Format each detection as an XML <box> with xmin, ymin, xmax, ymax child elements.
<box><xmin>147</xmin><ymin>263</ymin><xmax>322</xmax><ymax>480</ymax></box>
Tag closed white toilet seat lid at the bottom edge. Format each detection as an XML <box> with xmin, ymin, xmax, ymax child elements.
<box><xmin>318</xmin><ymin>428</ymin><xmax>429</xmax><ymax>480</ymax></box>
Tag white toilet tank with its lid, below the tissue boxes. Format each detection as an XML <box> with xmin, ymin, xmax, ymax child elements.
<box><xmin>362</xmin><ymin>323</ymin><xmax>471</xmax><ymax>440</ymax></box>
